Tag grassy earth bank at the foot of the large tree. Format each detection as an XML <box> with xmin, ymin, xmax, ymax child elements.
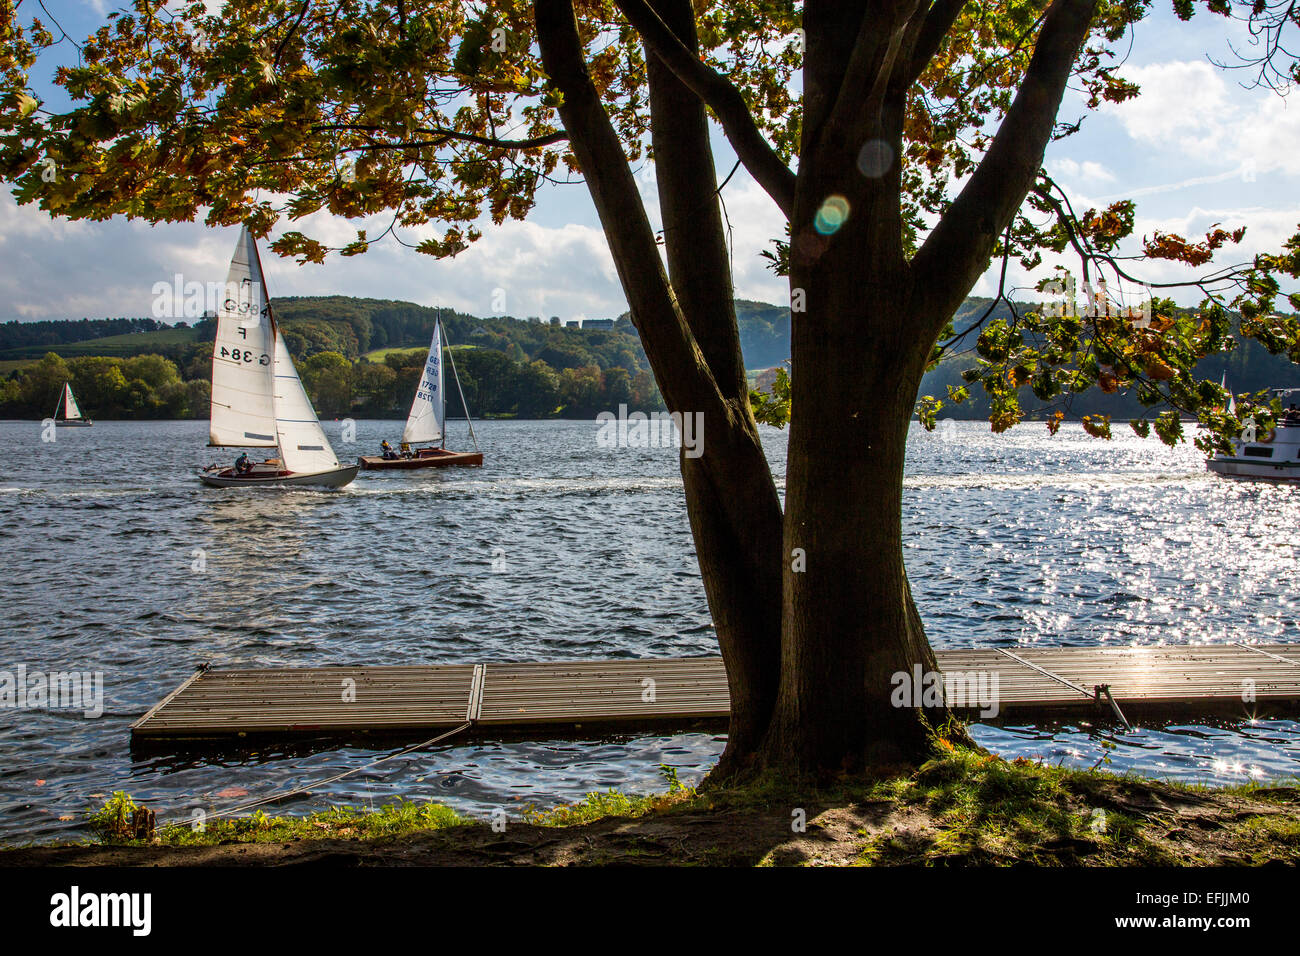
<box><xmin>0</xmin><ymin>749</ymin><xmax>1300</xmax><ymax>866</ymax></box>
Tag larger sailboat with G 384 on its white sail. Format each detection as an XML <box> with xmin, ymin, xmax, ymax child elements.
<box><xmin>199</xmin><ymin>226</ymin><xmax>358</xmax><ymax>488</ymax></box>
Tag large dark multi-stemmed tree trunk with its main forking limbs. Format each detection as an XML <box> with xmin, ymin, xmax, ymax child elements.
<box><xmin>534</xmin><ymin>0</ymin><xmax>1097</xmax><ymax>778</ymax></box>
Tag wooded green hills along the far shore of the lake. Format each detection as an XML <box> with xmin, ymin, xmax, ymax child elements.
<box><xmin>0</xmin><ymin>295</ymin><xmax>1300</xmax><ymax>419</ymax></box>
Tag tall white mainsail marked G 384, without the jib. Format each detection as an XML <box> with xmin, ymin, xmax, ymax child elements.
<box><xmin>208</xmin><ymin>226</ymin><xmax>276</xmax><ymax>447</ymax></box>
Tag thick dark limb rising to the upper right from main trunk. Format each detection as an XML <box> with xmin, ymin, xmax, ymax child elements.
<box><xmin>913</xmin><ymin>0</ymin><xmax>1097</xmax><ymax>324</ymax></box>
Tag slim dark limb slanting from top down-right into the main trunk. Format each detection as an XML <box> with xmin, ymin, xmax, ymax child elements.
<box><xmin>615</xmin><ymin>0</ymin><xmax>794</xmax><ymax>219</ymax></box>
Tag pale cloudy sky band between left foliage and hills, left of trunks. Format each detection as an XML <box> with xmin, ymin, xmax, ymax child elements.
<box><xmin>0</xmin><ymin>193</ymin><xmax>627</xmax><ymax>320</ymax></box>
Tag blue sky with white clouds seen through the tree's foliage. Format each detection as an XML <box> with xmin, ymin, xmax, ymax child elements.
<box><xmin>0</xmin><ymin>0</ymin><xmax>1300</xmax><ymax>321</ymax></box>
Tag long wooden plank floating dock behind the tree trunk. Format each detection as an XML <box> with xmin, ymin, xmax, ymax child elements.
<box><xmin>131</xmin><ymin>644</ymin><xmax>1300</xmax><ymax>741</ymax></box>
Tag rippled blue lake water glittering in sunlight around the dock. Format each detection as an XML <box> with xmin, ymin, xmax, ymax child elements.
<box><xmin>0</xmin><ymin>421</ymin><xmax>1300</xmax><ymax>840</ymax></box>
